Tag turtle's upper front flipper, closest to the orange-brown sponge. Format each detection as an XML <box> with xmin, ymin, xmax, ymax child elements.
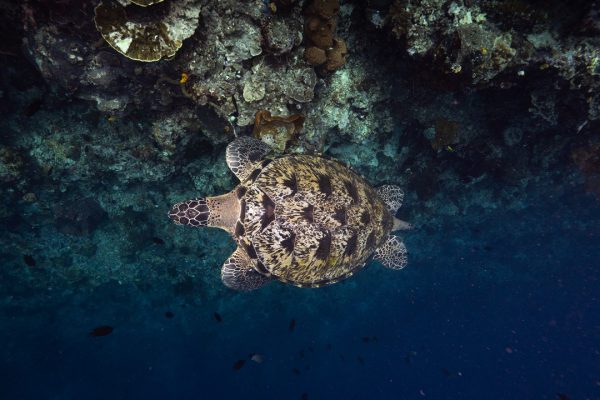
<box><xmin>225</xmin><ymin>136</ymin><xmax>270</xmax><ymax>182</ymax></box>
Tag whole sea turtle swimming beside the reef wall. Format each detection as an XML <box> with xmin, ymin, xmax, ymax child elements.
<box><xmin>169</xmin><ymin>136</ymin><xmax>410</xmax><ymax>290</ymax></box>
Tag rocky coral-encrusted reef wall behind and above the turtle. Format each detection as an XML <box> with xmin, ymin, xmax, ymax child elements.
<box><xmin>0</xmin><ymin>0</ymin><xmax>600</xmax><ymax>394</ymax></box>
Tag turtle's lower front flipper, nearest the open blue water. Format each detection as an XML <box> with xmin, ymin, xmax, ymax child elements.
<box><xmin>221</xmin><ymin>247</ymin><xmax>271</xmax><ymax>292</ymax></box>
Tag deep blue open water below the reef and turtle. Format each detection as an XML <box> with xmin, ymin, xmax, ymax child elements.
<box><xmin>0</xmin><ymin>182</ymin><xmax>600</xmax><ymax>399</ymax></box>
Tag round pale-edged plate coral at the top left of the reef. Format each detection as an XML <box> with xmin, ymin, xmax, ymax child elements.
<box><xmin>94</xmin><ymin>0</ymin><xmax>200</xmax><ymax>62</ymax></box>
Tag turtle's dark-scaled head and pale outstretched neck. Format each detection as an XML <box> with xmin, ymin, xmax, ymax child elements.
<box><xmin>169</xmin><ymin>191</ymin><xmax>240</xmax><ymax>233</ymax></box>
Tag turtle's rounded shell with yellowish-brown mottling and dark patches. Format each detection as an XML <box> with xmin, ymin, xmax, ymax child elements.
<box><xmin>235</xmin><ymin>155</ymin><xmax>393</xmax><ymax>287</ymax></box>
